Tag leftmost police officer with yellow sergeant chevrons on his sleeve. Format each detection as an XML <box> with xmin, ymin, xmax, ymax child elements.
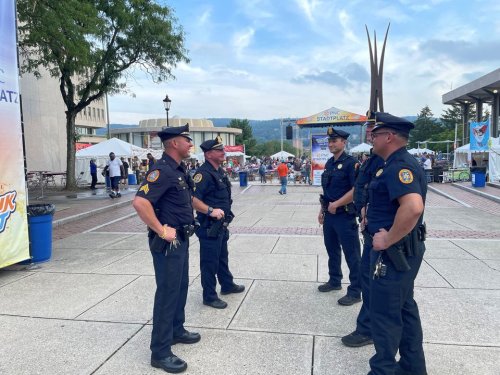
<box><xmin>133</xmin><ymin>125</ymin><xmax>200</xmax><ymax>373</ymax></box>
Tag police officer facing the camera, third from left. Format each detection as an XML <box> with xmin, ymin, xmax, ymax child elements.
<box><xmin>318</xmin><ymin>128</ymin><xmax>361</xmax><ymax>306</ymax></box>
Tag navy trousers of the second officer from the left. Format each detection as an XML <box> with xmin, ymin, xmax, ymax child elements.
<box><xmin>196</xmin><ymin>226</ymin><xmax>234</xmax><ymax>302</ymax></box>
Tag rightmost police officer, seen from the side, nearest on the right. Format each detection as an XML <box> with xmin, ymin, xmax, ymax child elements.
<box><xmin>367</xmin><ymin>113</ymin><xmax>427</xmax><ymax>375</ymax></box>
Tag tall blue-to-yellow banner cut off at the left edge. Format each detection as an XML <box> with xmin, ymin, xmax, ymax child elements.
<box><xmin>0</xmin><ymin>0</ymin><xmax>30</xmax><ymax>268</ymax></box>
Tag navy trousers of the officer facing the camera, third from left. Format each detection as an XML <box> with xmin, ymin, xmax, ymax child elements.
<box><xmin>323</xmin><ymin>212</ymin><xmax>361</xmax><ymax>298</ymax></box>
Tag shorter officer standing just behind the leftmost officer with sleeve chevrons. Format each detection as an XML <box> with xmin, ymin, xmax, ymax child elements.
<box><xmin>193</xmin><ymin>136</ymin><xmax>245</xmax><ymax>309</ymax></box>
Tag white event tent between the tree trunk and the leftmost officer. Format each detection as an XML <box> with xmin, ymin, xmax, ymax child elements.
<box><xmin>75</xmin><ymin>138</ymin><xmax>155</xmax><ymax>182</ymax></box>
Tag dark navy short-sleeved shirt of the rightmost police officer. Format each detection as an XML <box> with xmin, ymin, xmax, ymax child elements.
<box><xmin>367</xmin><ymin>147</ymin><xmax>427</xmax><ymax>234</ymax></box>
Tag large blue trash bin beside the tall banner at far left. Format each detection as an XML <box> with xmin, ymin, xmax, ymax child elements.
<box><xmin>28</xmin><ymin>204</ymin><xmax>56</xmax><ymax>263</ymax></box>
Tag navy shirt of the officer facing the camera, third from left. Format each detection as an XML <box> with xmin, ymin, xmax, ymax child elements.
<box><xmin>321</xmin><ymin>152</ymin><xmax>359</xmax><ymax>202</ymax></box>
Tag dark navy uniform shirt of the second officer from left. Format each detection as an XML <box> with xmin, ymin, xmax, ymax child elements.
<box><xmin>193</xmin><ymin>162</ymin><xmax>232</xmax><ymax>222</ymax></box>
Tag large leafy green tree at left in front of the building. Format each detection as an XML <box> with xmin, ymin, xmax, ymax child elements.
<box><xmin>17</xmin><ymin>0</ymin><xmax>189</xmax><ymax>189</ymax></box>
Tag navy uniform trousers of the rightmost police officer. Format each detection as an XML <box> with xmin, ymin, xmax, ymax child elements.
<box><xmin>370</xmin><ymin>242</ymin><xmax>427</xmax><ymax>375</ymax></box>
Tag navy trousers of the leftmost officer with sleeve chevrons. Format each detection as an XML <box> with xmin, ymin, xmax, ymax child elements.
<box><xmin>149</xmin><ymin>238</ymin><xmax>189</xmax><ymax>360</ymax></box>
